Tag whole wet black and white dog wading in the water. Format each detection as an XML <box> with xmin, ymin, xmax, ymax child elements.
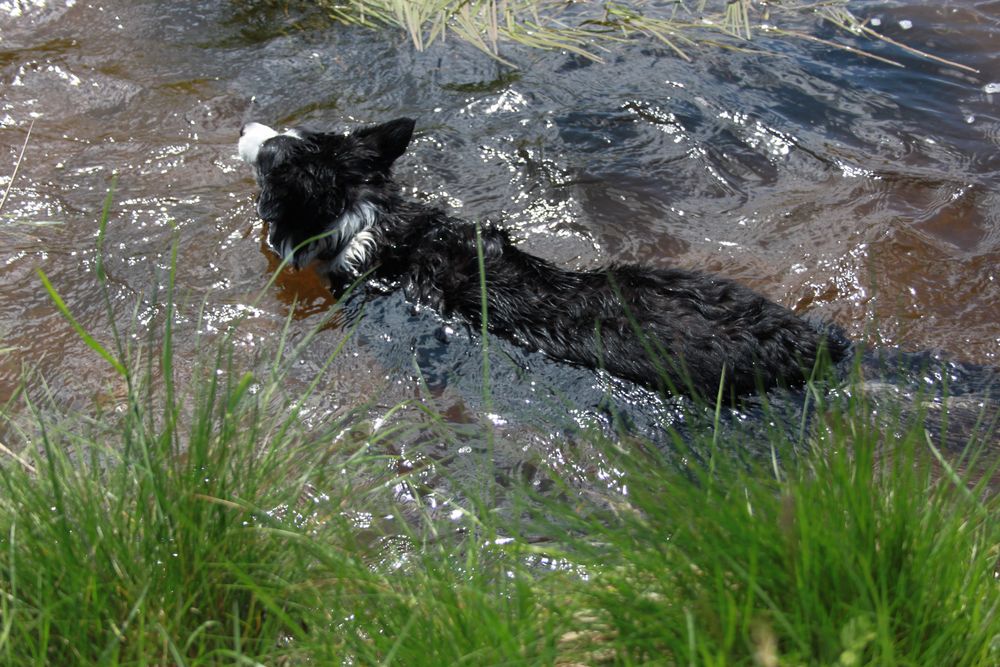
<box><xmin>239</xmin><ymin>118</ymin><xmax>845</xmax><ymax>398</ymax></box>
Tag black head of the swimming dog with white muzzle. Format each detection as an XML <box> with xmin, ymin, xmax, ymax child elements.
<box><xmin>239</xmin><ymin>118</ymin><xmax>414</xmax><ymax>277</ymax></box>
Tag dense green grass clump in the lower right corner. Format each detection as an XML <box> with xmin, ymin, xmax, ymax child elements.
<box><xmin>536</xmin><ymin>406</ymin><xmax>1000</xmax><ymax>665</ymax></box>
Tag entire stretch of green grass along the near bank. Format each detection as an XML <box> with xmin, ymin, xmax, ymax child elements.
<box><xmin>0</xmin><ymin>207</ymin><xmax>1000</xmax><ymax>666</ymax></box>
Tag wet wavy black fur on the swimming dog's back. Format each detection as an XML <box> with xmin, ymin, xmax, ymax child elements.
<box><xmin>378</xmin><ymin>214</ymin><xmax>845</xmax><ymax>398</ymax></box>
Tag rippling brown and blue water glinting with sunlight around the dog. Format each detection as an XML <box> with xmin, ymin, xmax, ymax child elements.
<box><xmin>0</xmin><ymin>0</ymin><xmax>1000</xmax><ymax>486</ymax></box>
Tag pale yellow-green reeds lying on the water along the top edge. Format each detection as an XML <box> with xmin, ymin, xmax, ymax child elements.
<box><xmin>238</xmin><ymin>0</ymin><xmax>970</xmax><ymax>70</ymax></box>
